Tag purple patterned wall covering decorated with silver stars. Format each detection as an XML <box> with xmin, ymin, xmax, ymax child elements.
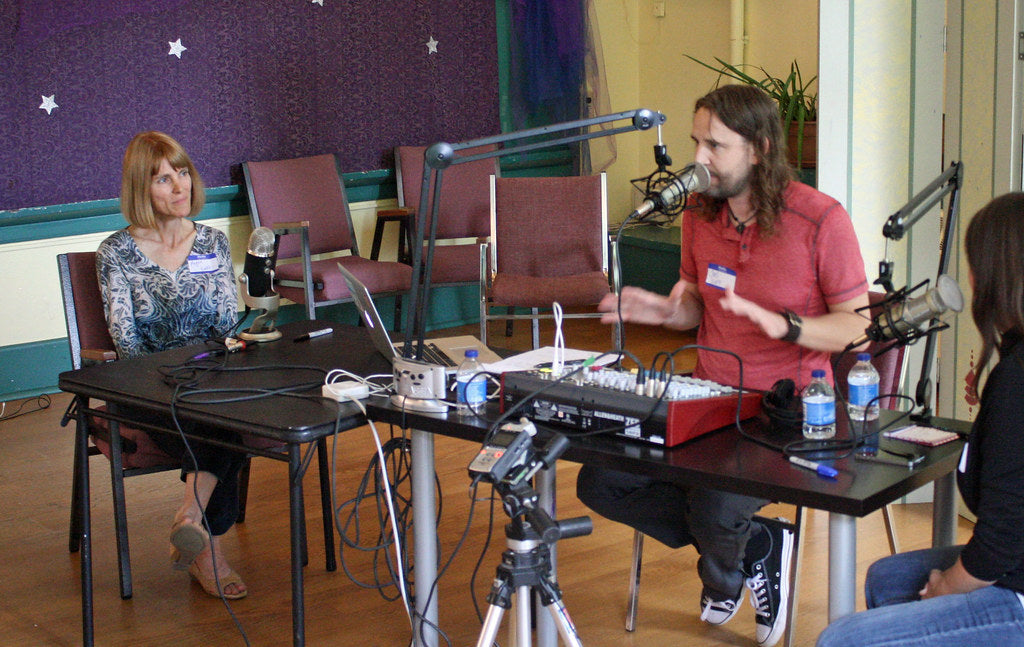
<box><xmin>0</xmin><ymin>0</ymin><xmax>500</xmax><ymax>210</ymax></box>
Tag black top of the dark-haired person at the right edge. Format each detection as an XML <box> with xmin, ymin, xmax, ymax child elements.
<box><xmin>956</xmin><ymin>335</ymin><xmax>1024</xmax><ymax>592</ymax></box>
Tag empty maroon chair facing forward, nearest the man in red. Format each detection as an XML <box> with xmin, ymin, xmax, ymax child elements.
<box><xmin>480</xmin><ymin>173</ymin><xmax>621</xmax><ymax>348</ymax></box>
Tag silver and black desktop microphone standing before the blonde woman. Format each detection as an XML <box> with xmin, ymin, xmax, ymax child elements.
<box><xmin>239</xmin><ymin>227</ymin><xmax>282</xmax><ymax>342</ymax></box>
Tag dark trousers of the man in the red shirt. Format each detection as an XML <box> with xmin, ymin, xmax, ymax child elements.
<box><xmin>577</xmin><ymin>465</ymin><xmax>769</xmax><ymax>600</ymax></box>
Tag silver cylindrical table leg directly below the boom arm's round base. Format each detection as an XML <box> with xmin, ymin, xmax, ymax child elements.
<box><xmin>412</xmin><ymin>429</ymin><xmax>437</xmax><ymax>647</ymax></box>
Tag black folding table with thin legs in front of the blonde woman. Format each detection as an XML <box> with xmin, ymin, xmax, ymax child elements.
<box><xmin>58</xmin><ymin>321</ymin><xmax>391</xmax><ymax>645</ymax></box>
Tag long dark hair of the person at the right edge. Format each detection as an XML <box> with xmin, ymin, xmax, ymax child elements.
<box><xmin>964</xmin><ymin>192</ymin><xmax>1024</xmax><ymax>369</ymax></box>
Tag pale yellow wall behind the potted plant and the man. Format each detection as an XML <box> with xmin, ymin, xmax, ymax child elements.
<box><xmin>595</xmin><ymin>0</ymin><xmax>817</xmax><ymax>222</ymax></box>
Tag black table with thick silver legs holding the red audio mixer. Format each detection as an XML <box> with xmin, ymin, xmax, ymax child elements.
<box><xmin>367</xmin><ymin>398</ymin><xmax>970</xmax><ymax>645</ymax></box>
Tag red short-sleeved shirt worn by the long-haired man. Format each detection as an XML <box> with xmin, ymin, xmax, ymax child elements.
<box><xmin>679</xmin><ymin>182</ymin><xmax>867</xmax><ymax>389</ymax></box>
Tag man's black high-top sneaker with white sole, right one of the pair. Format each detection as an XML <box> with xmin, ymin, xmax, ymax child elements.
<box><xmin>746</xmin><ymin>517</ymin><xmax>793</xmax><ymax>647</ymax></box>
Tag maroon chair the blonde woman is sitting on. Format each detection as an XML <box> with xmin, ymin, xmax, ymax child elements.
<box><xmin>57</xmin><ymin>252</ymin><xmax>336</xmax><ymax>600</ymax></box>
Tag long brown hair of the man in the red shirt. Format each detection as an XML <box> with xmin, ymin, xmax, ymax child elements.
<box><xmin>693</xmin><ymin>85</ymin><xmax>794</xmax><ymax>236</ymax></box>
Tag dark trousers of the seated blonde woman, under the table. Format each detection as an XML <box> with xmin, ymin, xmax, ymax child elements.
<box><xmin>122</xmin><ymin>407</ymin><xmax>246</xmax><ymax>536</ymax></box>
